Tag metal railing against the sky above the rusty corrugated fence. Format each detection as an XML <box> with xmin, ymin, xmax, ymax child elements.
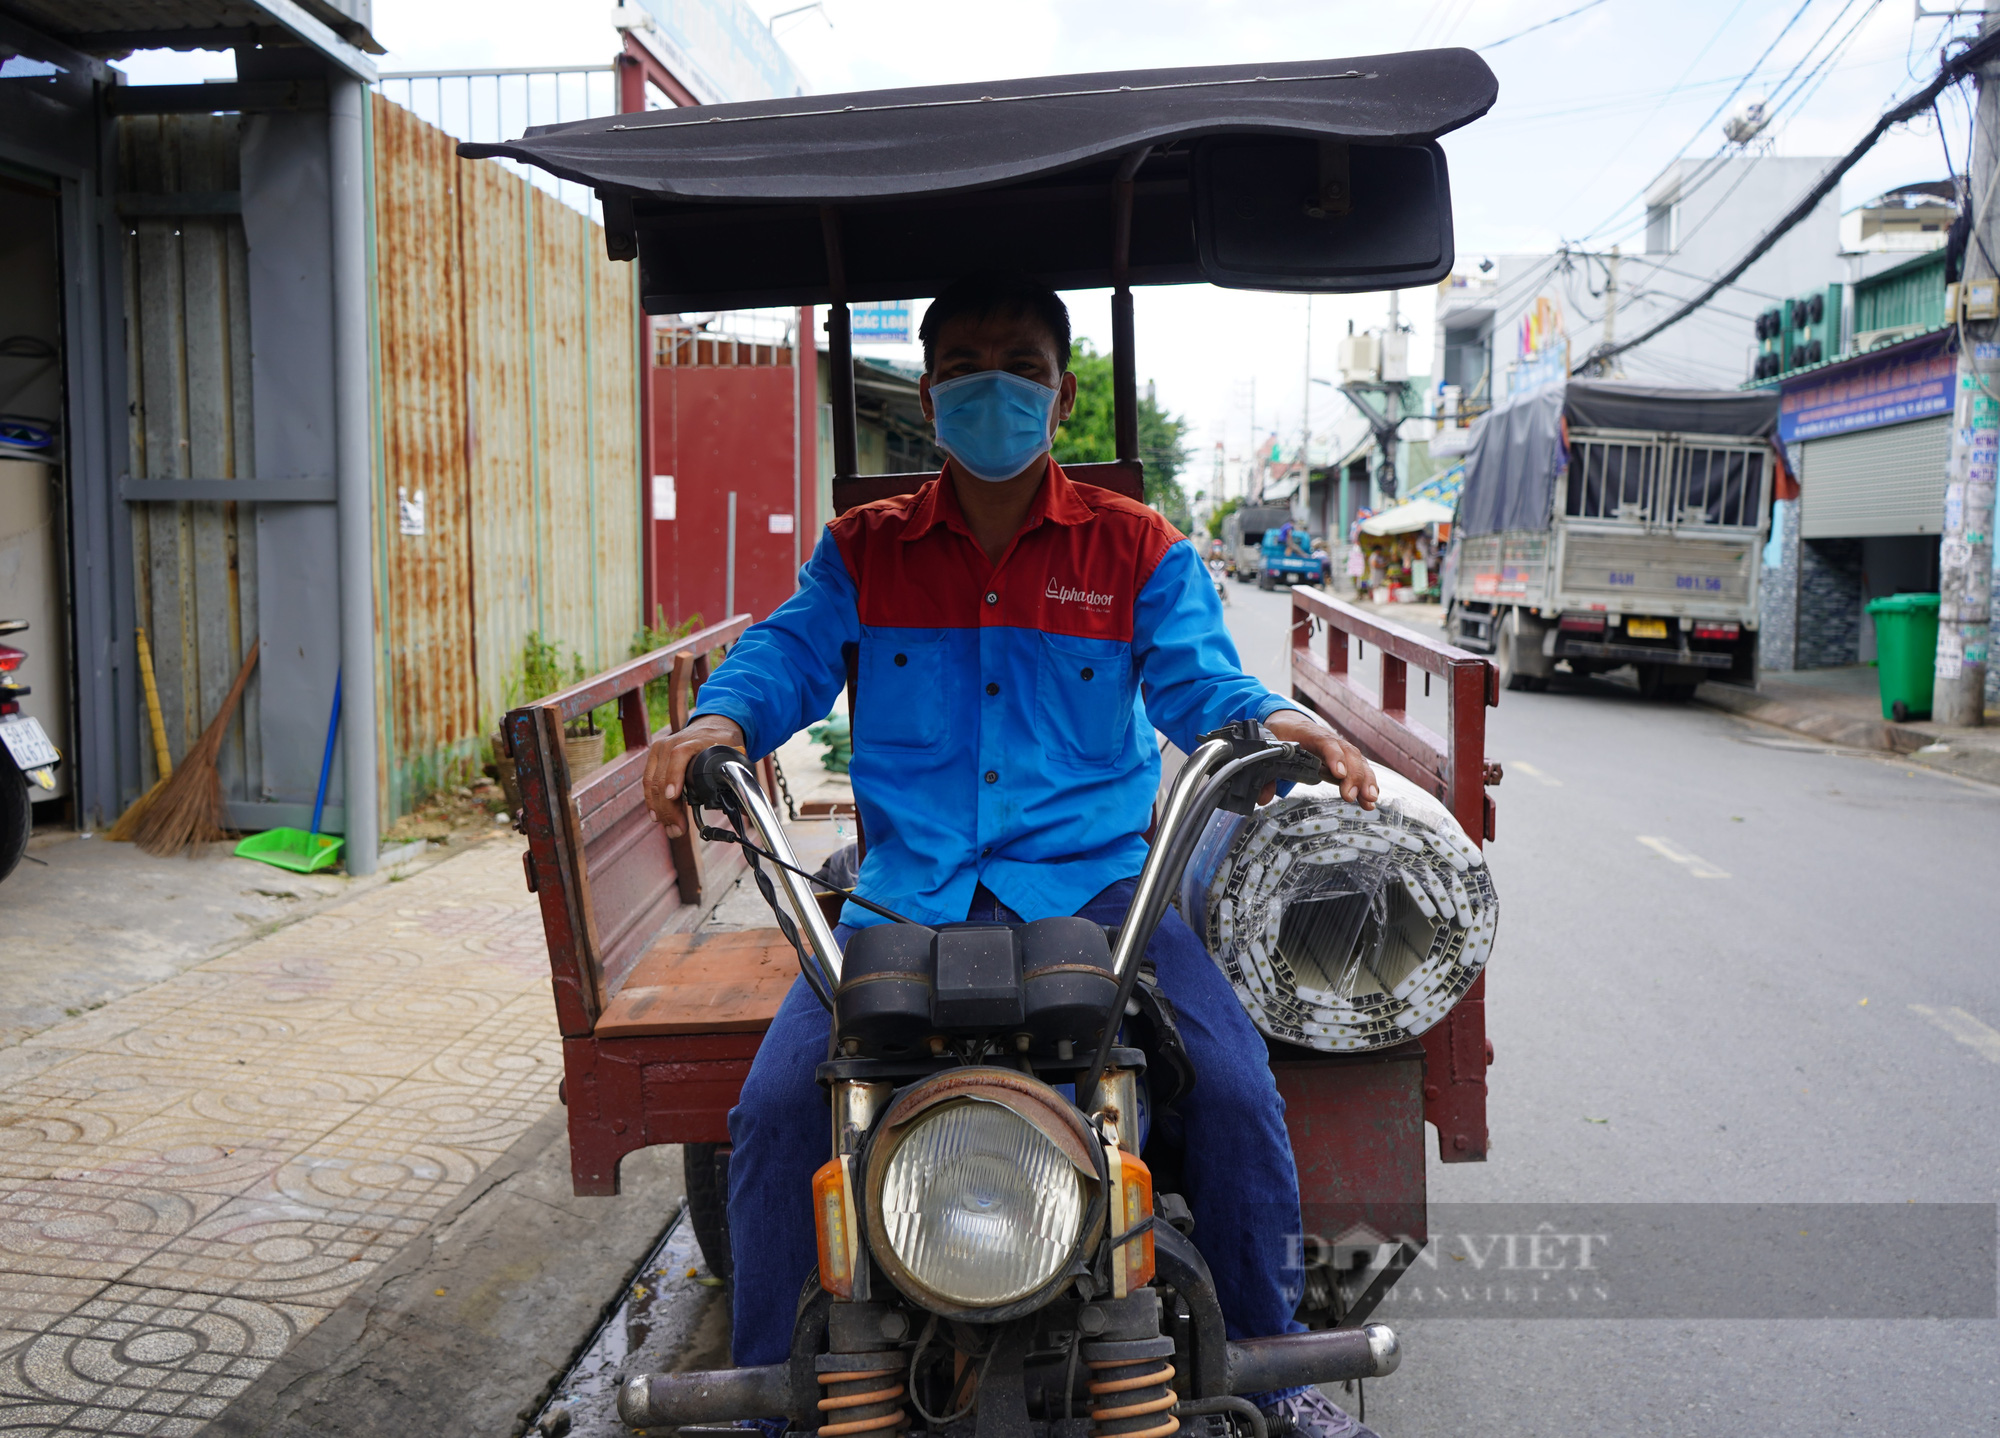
<box><xmin>374</xmin><ymin>64</ymin><xmax>618</xmax><ymax>224</ymax></box>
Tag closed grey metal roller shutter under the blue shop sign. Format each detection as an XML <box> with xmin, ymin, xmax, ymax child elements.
<box><xmin>1798</xmin><ymin>414</ymin><xmax>1952</xmax><ymax>540</ymax></box>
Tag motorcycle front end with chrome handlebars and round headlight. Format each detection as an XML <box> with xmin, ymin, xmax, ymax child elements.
<box><xmin>618</xmin><ymin>724</ymin><xmax>1400</xmax><ymax>1438</ymax></box>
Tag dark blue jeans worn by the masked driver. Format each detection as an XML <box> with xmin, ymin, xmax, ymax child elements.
<box><xmin>730</xmin><ymin>880</ymin><xmax>1304</xmax><ymax>1366</ymax></box>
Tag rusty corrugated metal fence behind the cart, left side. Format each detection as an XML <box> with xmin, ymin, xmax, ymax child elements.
<box><xmin>372</xmin><ymin>96</ymin><xmax>640</xmax><ymax>814</ymax></box>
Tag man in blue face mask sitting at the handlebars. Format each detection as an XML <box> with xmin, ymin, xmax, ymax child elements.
<box><xmin>644</xmin><ymin>274</ymin><xmax>1376</xmax><ymax>1438</ymax></box>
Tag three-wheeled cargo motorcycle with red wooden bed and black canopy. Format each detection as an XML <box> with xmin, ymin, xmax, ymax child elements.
<box><xmin>480</xmin><ymin>50</ymin><xmax>1498</xmax><ymax>1438</ymax></box>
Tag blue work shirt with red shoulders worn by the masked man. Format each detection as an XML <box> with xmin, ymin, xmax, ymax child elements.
<box><xmin>694</xmin><ymin>460</ymin><xmax>1298</xmax><ymax>926</ymax></box>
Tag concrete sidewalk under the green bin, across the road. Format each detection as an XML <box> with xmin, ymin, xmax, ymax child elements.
<box><xmin>1694</xmin><ymin>664</ymin><xmax>2000</xmax><ymax>784</ymax></box>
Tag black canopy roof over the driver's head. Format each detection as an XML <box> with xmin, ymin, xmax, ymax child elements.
<box><xmin>460</xmin><ymin>50</ymin><xmax>1496</xmax><ymax>312</ymax></box>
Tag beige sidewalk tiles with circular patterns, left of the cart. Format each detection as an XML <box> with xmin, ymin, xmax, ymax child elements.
<box><xmin>0</xmin><ymin>842</ymin><xmax>562</xmax><ymax>1438</ymax></box>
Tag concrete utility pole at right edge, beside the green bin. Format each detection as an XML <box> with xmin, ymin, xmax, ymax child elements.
<box><xmin>1930</xmin><ymin>10</ymin><xmax>2000</xmax><ymax>726</ymax></box>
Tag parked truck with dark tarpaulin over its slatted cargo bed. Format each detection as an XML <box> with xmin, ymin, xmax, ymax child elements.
<box><xmin>1444</xmin><ymin>380</ymin><xmax>1782</xmax><ymax>700</ymax></box>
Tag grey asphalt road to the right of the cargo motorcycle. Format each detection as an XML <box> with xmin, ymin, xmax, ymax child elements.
<box><xmin>1228</xmin><ymin>586</ymin><xmax>2000</xmax><ymax>1438</ymax></box>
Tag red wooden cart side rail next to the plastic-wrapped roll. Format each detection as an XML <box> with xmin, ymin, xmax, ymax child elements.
<box><xmin>1292</xmin><ymin>586</ymin><xmax>1500</xmax><ymax>1164</ymax></box>
